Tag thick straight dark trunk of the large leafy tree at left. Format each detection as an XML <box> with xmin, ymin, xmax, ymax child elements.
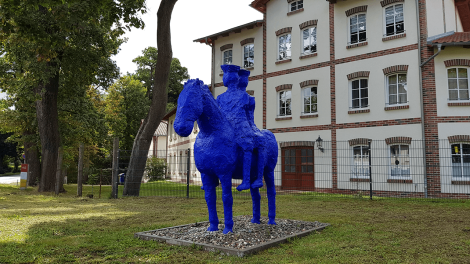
<box><xmin>36</xmin><ymin>63</ymin><xmax>63</xmax><ymax>192</ymax></box>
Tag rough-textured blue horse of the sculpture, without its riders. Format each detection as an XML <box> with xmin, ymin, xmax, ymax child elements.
<box><xmin>174</xmin><ymin>79</ymin><xmax>278</xmax><ymax>234</ymax></box>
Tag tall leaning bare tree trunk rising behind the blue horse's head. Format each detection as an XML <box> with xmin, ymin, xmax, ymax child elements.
<box><xmin>123</xmin><ymin>0</ymin><xmax>177</xmax><ymax>196</ymax></box>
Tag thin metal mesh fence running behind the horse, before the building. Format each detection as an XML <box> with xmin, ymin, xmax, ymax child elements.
<box><xmin>114</xmin><ymin>139</ymin><xmax>470</xmax><ymax>199</ymax></box>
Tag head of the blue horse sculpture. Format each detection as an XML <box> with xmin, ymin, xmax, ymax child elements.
<box><xmin>174</xmin><ymin>79</ymin><xmax>208</xmax><ymax>137</ymax></box>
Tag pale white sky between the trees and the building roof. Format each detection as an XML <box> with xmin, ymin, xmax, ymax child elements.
<box><xmin>0</xmin><ymin>0</ymin><xmax>263</xmax><ymax>98</ymax></box>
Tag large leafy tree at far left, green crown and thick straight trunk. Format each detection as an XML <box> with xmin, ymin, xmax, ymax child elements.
<box><xmin>0</xmin><ymin>0</ymin><xmax>146</xmax><ymax>192</ymax></box>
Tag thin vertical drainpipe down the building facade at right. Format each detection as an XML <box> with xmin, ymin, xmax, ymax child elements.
<box><xmin>416</xmin><ymin>0</ymin><xmax>428</xmax><ymax>198</ymax></box>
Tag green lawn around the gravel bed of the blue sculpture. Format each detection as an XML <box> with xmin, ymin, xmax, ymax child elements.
<box><xmin>0</xmin><ymin>185</ymin><xmax>470</xmax><ymax>263</ymax></box>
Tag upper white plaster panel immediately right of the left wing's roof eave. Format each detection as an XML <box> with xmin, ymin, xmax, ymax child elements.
<box><xmin>266</xmin><ymin>0</ymin><xmax>330</xmax><ymax>73</ymax></box>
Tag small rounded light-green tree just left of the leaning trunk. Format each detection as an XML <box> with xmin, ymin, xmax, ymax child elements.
<box><xmin>105</xmin><ymin>75</ymin><xmax>150</xmax><ymax>150</ymax></box>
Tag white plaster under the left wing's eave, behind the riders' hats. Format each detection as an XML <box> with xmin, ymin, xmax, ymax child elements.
<box><xmin>214</xmin><ymin>25</ymin><xmax>263</xmax><ymax>83</ymax></box>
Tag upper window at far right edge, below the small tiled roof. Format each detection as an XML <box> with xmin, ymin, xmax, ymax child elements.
<box><xmin>447</xmin><ymin>68</ymin><xmax>469</xmax><ymax>100</ymax></box>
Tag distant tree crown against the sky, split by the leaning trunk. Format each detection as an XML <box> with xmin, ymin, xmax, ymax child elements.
<box><xmin>132</xmin><ymin>47</ymin><xmax>189</xmax><ymax>111</ymax></box>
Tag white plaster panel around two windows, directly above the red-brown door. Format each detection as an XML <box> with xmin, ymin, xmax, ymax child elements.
<box><xmin>266</xmin><ymin>67</ymin><xmax>331</xmax><ymax>129</ymax></box>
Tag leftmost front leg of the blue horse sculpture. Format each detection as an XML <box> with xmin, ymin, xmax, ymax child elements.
<box><xmin>201</xmin><ymin>173</ymin><xmax>219</xmax><ymax>232</ymax></box>
